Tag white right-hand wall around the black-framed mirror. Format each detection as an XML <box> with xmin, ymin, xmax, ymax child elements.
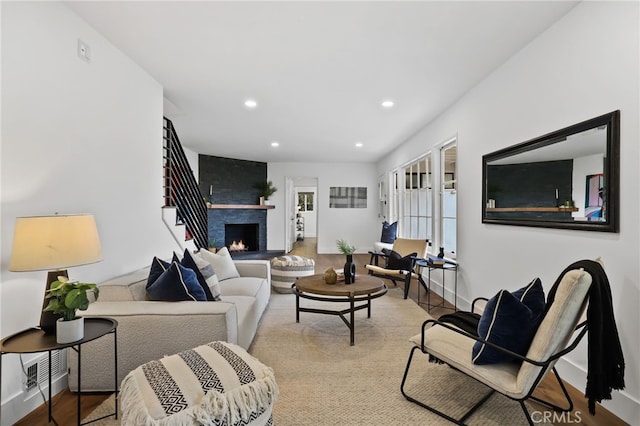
<box><xmin>377</xmin><ymin>2</ymin><xmax>640</xmax><ymax>424</ymax></box>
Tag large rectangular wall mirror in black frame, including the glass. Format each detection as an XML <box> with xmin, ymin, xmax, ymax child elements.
<box><xmin>482</xmin><ymin>111</ymin><xmax>620</xmax><ymax>232</ymax></box>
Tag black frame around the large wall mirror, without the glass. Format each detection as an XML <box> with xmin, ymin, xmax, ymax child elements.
<box><xmin>482</xmin><ymin>110</ymin><xmax>620</xmax><ymax>232</ymax></box>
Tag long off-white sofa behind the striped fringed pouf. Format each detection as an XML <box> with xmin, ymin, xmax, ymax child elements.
<box><xmin>67</xmin><ymin>260</ymin><xmax>271</xmax><ymax>392</ymax></box>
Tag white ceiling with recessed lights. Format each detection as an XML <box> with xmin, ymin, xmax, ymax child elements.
<box><xmin>67</xmin><ymin>1</ymin><xmax>576</xmax><ymax>162</ymax></box>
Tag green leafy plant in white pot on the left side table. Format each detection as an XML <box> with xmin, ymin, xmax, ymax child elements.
<box><xmin>44</xmin><ymin>277</ymin><xmax>99</xmax><ymax>343</ymax></box>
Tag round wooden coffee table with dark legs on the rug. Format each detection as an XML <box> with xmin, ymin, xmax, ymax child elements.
<box><xmin>292</xmin><ymin>274</ymin><xmax>387</xmax><ymax>346</ymax></box>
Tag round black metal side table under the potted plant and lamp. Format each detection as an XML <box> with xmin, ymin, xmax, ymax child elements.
<box><xmin>0</xmin><ymin>317</ymin><xmax>118</xmax><ymax>425</ymax></box>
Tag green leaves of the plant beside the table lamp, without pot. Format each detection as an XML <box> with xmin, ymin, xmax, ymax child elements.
<box><xmin>44</xmin><ymin>277</ymin><xmax>99</xmax><ymax>321</ymax></box>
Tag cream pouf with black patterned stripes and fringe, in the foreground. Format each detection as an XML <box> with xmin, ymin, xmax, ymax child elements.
<box><xmin>120</xmin><ymin>342</ymin><xmax>278</xmax><ymax>426</ymax></box>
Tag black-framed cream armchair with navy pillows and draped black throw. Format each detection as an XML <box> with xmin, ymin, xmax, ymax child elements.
<box><xmin>400</xmin><ymin>259</ymin><xmax>624</xmax><ymax>426</ymax></box>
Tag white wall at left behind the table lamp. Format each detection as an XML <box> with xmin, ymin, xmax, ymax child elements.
<box><xmin>0</xmin><ymin>2</ymin><xmax>182</xmax><ymax>425</ymax></box>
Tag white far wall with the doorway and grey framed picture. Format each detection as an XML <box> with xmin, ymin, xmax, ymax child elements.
<box><xmin>267</xmin><ymin>163</ymin><xmax>381</xmax><ymax>253</ymax></box>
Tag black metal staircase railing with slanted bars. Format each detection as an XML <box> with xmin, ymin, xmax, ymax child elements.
<box><xmin>162</xmin><ymin>117</ymin><xmax>209</xmax><ymax>249</ymax></box>
